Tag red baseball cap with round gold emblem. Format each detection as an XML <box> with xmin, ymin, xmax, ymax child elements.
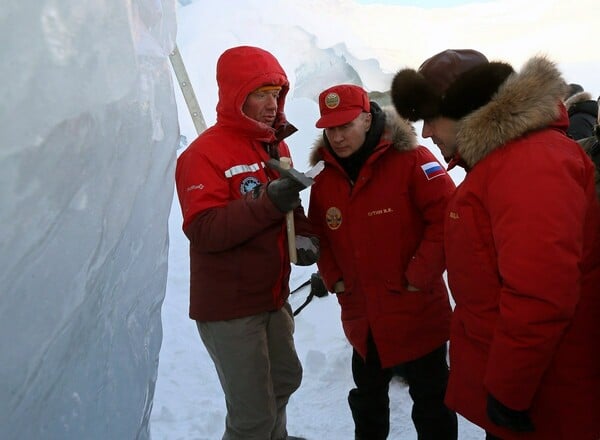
<box><xmin>315</xmin><ymin>84</ymin><xmax>371</xmax><ymax>128</ymax></box>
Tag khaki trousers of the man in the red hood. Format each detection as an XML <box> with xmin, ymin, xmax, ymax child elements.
<box><xmin>196</xmin><ymin>303</ymin><xmax>302</xmax><ymax>440</ymax></box>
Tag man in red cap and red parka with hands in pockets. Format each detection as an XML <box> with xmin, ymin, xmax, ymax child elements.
<box><xmin>308</xmin><ymin>84</ymin><xmax>457</xmax><ymax>440</ymax></box>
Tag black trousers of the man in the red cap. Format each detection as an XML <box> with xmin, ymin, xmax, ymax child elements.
<box><xmin>348</xmin><ymin>335</ymin><xmax>458</xmax><ymax>440</ymax></box>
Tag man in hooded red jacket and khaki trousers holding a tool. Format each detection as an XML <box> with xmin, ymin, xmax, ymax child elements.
<box><xmin>175</xmin><ymin>46</ymin><xmax>318</xmax><ymax>440</ymax></box>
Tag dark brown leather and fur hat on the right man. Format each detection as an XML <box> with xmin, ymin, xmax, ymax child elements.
<box><xmin>391</xmin><ymin>49</ymin><xmax>514</xmax><ymax>121</ymax></box>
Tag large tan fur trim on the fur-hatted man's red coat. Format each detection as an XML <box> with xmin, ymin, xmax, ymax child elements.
<box><xmin>457</xmin><ymin>56</ymin><xmax>568</xmax><ymax>168</ymax></box>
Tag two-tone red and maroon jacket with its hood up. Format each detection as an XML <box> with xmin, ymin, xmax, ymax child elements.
<box><xmin>175</xmin><ymin>47</ymin><xmax>308</xmax><ymax>321</ymax></box>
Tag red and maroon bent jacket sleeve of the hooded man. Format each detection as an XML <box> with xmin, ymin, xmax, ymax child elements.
<box><xmin>175</xmin><ymin>149</ymin><xmax>284</xmax><ymax>252</ymax></box>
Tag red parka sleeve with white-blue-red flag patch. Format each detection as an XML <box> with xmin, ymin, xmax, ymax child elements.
<box><xmin>406</xmin><ymin>147</ymin><xmax>455</xmax><ymax>291</ymax></box>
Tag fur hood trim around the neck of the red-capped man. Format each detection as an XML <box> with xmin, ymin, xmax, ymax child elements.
<box><xmin>309</xmin><ymin>106</ymin><xmax>418</xmax><ymax>166</ymax></box>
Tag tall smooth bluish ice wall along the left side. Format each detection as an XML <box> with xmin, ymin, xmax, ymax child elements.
<box><xmin>0</xmin><ymin>0</ymin><xmax>178</xmax><ymax>440</ymax></box>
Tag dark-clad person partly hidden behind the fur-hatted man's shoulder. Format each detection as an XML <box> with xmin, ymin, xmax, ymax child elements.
<box><xmin>564</xmin><ymin>84</ymin><xmax>598</xmax><ymax>141</ymax></box>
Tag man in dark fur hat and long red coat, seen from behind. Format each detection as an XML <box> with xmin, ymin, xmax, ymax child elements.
<box><xmin>392</xmin><ymin>50</ymin><xmax>600</xmax><ymax>440</ymax></box>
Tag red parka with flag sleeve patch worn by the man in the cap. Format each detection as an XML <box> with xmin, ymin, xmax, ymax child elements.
<box><xmin>308</xmin><ymin>107</ymin><xmax>454</xmax><ymax>368</ymax></box>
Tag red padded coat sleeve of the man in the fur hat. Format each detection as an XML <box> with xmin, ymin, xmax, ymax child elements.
<box><xmin>483</xmin><ymin>145</ymin><xmax>586</xmax><ymax>410</ymax></box>
